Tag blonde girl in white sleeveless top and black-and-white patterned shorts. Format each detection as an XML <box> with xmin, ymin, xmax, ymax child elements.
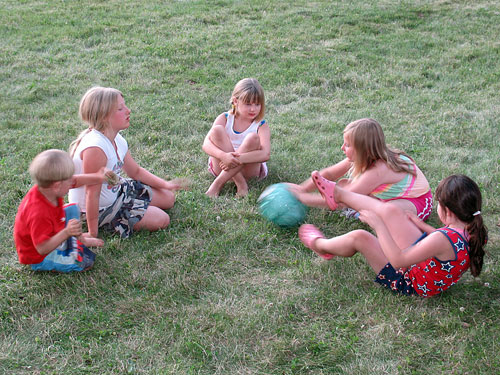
<box><xmin>69</xmin><ymin>87</ymin><xmax>188</xmax><ymax>238</ymax></box>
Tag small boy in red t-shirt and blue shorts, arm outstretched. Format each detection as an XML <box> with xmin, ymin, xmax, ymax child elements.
<box><xmin>14</xmin><ymin>150</ymin><xmax>109</xmax><ymax>272</ymax></box>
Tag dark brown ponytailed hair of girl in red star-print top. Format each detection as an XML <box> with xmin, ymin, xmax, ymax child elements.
<box><xmin>436</xmin><ymin>175</ymin><xmax>488</xmax><ymax>276</ymax></box>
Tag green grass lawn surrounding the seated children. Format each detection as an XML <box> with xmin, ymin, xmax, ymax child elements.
<box><xmin>0</xmin><ymin>0</ymin><xmax>500</xmax><ymax>374</ymax></box>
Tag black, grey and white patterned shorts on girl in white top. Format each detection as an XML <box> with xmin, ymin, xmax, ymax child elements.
<box><xmin>99</xmin><ymin>179</ymin><xmax>153</xmax><ymax>238</ymax></box>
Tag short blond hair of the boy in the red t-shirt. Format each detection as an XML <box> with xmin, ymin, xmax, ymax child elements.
<box><xmin>29</xmin><ymin>150</ymin><xmax>75</xmax><ymax>188</ymax></box>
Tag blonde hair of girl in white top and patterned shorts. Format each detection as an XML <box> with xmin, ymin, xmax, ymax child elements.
<box><xmin>69</xmin><ymin>86</ymin><xmax>123</xmax><ymax>157</ymax></box>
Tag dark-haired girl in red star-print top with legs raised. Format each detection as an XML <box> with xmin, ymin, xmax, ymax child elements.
<box><xmin>297</xmin><ymin>171</ymin><xmax>488</xmax><ymax>297</ymax></box>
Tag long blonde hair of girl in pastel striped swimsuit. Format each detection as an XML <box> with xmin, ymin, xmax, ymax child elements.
<box><xmin>344</xmin><ymin>118</ymin><xmax>416</xmax><ymax>179</ymax></box>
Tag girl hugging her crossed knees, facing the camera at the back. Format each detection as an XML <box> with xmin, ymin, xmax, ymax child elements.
<box><xmin>202</xmin><ymin>78</ymin><xmax>271</xmax><ymax>198</ymax></box>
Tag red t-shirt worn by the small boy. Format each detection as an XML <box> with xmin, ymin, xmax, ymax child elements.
<box><xmin>14</xmin><ymin>185</ymin><xmax>65</xmax><ymax>264</ymax></box>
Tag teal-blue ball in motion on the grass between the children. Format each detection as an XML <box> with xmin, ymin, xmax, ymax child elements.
<box><xmin>258</xmin><ymin>183</ymin><xmax>307</xmax><ymax>228</ymax></box>
